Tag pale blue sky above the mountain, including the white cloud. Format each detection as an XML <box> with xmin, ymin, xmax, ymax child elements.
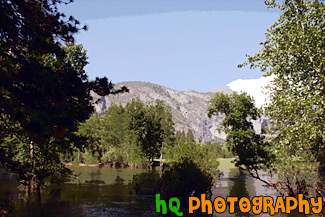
<box><xmin>60</xmin><ymin>0</ymin><xmax>280</xmax><ymax>106</ymax></box>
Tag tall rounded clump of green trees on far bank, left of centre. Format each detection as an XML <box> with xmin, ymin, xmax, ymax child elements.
<box><xmin>78</xmin><ymin>99</ymin><xmax>174</xmax><ymax>165</ymax></box>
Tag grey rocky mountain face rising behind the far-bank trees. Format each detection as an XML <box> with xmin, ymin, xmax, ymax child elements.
<box><xmin>92</xmin><ymin>81</ymin><xmax>267</xmax><ymax>142</ymax></box>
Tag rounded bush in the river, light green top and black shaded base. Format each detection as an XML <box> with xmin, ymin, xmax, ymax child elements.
<box><xmin>158</xmin><ymin>138</ymin><xmax>220</xmax><ymax>207</ymax></box>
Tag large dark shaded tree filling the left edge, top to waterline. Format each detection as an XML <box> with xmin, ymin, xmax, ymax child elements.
<box><xmin>0</xmin><ymin>0</ymin><xmax>126</xmax><ymax>195</ymax></box>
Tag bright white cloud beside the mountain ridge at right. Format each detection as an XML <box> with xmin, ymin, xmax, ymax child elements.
<box><xmin>227</xmin><ymin>76</ymin><xmax>273</xmax><ymax>108</ymax></box>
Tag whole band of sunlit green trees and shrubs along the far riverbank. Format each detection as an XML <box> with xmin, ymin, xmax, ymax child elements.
<box><xmin>69</xmin><ymin>99</ymin><xmax>224</xmax><ymax>171</ymax></box>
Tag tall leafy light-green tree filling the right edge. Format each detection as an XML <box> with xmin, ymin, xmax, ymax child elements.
<box><xmin>242</xmin><ymin>0</ymin><xmax>325</xmax><ymax>196</ymax></box>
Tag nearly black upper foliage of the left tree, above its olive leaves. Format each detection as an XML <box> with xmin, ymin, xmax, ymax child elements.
<box><xmin>0</xmin><ymin>0</ymin><xmax>91</xmax><ymax>143</ymax></box>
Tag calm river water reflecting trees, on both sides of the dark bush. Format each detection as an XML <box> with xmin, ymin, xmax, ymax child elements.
<box><xmin>0</xmin><ymin>167</ymin><xmax>322</xmax><ymax>217</ymax></box>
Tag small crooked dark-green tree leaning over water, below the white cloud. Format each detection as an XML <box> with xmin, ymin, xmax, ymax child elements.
<box><xmin>207</xmin><ymin>92</ymin><xmax>272</xmax><ymax>173</ymax></box>
